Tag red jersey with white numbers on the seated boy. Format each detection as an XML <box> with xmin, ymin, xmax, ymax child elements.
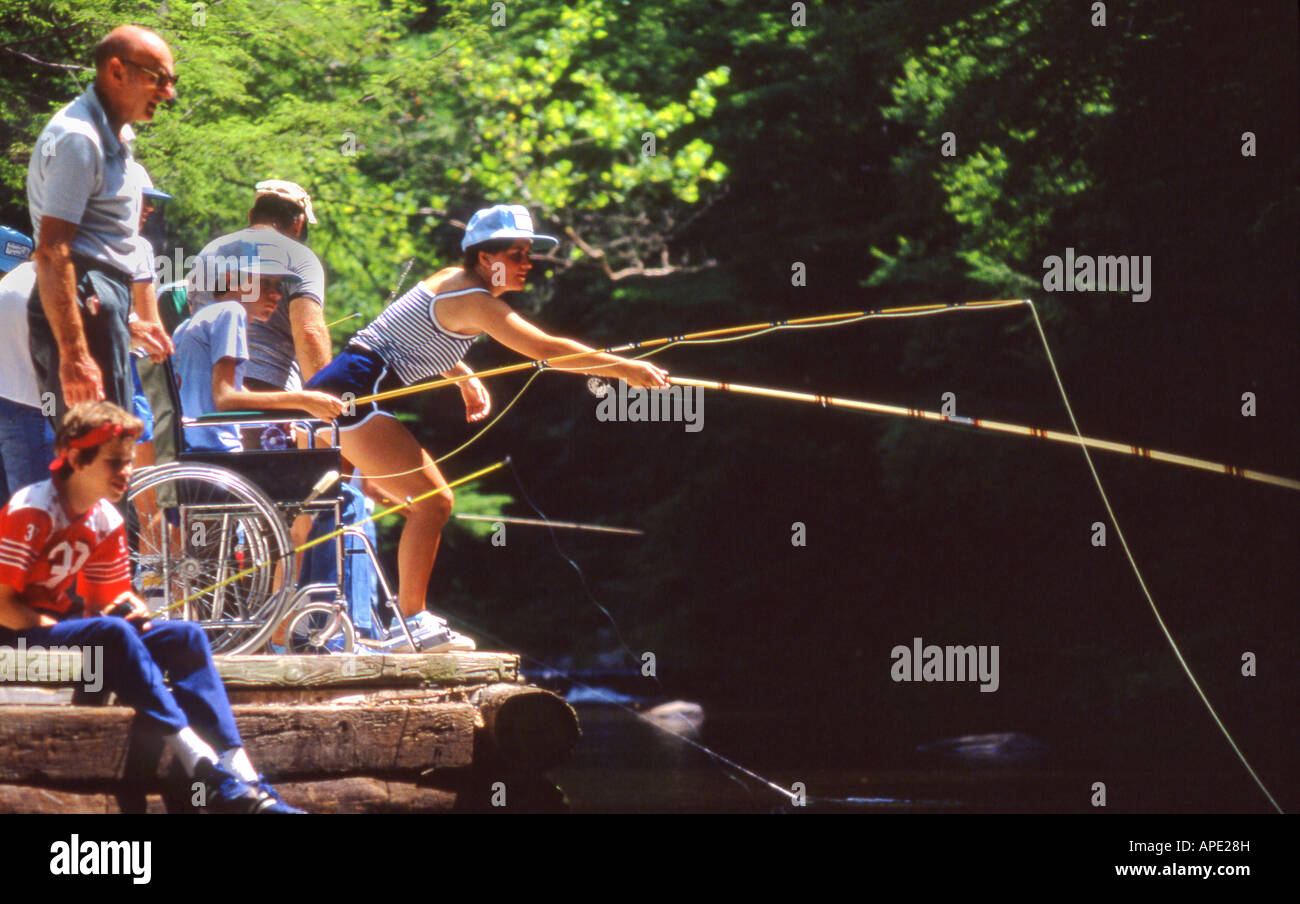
<box><xmin>0</xmin><ymin>480</ymin><xmax>131</xmax><ymax>618</ymax></box>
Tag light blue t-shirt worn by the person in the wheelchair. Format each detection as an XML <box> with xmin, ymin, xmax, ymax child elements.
<box><xmin>172</xmin><ymin>302</ymin><xmax>248</xmax><ymax>451</ymax></box>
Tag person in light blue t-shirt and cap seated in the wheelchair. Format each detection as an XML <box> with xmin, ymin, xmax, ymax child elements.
<box><xmin>172</xmin><ymin>242</ymin><xmax>345</xmax><ymax>451</ymax></box>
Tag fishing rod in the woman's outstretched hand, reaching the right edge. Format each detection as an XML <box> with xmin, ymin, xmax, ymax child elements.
<box><xmin>671</xmin><ymin>377</ymin><xmax>1300</xmax><ymax>490</ymax></box>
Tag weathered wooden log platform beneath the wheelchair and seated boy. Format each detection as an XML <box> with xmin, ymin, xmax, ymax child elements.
<box><xmin>0</xmin><ymin>650</ymin><xmax>579</xmax><ymax>813</ymax></box>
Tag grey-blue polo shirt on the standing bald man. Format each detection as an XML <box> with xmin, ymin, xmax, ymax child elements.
<box><xmin>27</xmin><ymin>85</ymin><xmax>143</xmax><ymax>276</ymax></box>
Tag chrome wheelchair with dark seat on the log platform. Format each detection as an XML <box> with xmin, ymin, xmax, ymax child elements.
<box><xmin>126</xmin><ymin>362</ymin><xmax>416</xmax><ymax>653</ymax></box>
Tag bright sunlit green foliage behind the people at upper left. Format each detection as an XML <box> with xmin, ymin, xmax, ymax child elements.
<box><xmin>0</xmin><ymin>0</ymin><xmax>727</xmax><ymax>325</ymax></box>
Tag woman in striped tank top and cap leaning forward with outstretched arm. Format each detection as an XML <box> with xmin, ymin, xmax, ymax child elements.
<box><xmin>308</xmin><ymin>204</ymin><xmax>668</xmax><ymax>649</ymax></box>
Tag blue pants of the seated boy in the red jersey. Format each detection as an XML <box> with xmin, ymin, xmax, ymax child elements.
<box><xmin>0</xmin><ymin>615</ymin><xmax>243</xmax><ymax>753</ymax></box>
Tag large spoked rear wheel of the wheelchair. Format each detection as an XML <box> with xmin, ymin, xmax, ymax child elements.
<box><xmin>126</xmin><ymin>462</ymin><xmax>296</xmax><ymax>653</ymax></box>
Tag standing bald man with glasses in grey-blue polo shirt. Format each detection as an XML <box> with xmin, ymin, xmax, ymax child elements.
<box><xmin>27</xmin><ymin>25</ymin><xmax>177</xmax><ymax>419</ymax></box>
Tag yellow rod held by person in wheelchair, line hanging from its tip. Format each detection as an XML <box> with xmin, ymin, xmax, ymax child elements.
<box><xmin>354</xmin><ymin>298</ymin><xmax>1030</xmax><ymax>405</ymax></box>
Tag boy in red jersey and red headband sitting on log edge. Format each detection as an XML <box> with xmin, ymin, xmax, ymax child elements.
<box><xmin>0</xmin><ymin>402</ymin><xmax>302</xmax><ymax>813</ymax></box>
